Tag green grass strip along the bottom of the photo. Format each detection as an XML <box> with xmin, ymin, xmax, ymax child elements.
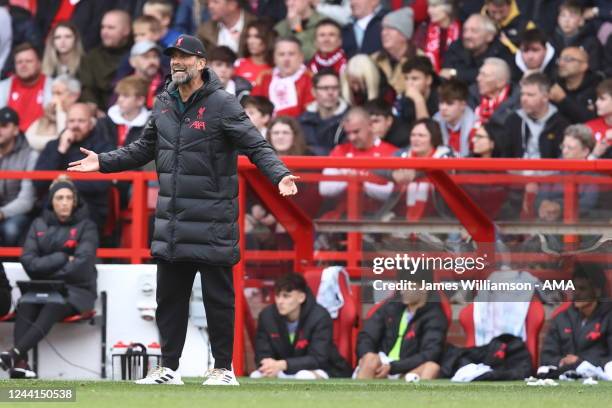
<box><xmin>0</xmin><ymin>378</ymin><xmax>612</xmax><ymax>408</ymax></box>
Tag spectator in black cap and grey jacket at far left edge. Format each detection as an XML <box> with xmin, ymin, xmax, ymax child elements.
<box><xmin>0</xmin><ymin>107</ymin><xmax>38</xmax><ymax>247</ymax></box>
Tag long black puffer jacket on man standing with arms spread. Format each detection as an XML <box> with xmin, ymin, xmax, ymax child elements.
<box><xmin>99</xmin><ymin>68</ymin><xmax>290</xmax><ymax>266</ymax></box>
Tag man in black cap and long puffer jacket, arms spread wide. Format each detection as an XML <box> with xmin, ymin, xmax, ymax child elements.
<box><xmin>70</xmin><ymin>35</ymin><xmax>297</xmax><ymax>385</ymax></box>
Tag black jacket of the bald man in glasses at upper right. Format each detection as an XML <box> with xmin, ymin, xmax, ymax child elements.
<box><xmin>557</xmin><ymin>71</ymin><xmax>602</xmax><ymax>123</ymax></box>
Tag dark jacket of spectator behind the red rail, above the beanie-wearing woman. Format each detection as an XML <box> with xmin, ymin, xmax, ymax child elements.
<box><xmin>34</xmin><ymin>126</ymin><xmax>115</xmax><ymax>227</ymax></box>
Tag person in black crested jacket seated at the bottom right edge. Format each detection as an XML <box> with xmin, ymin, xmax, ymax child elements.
<box><xmin>538</xmin><ymin>263</ymin><xmax>612</xmax><ymax>378</ymax></box>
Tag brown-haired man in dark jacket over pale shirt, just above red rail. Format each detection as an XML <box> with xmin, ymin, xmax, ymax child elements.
<box><xmin>504</xmin><ymin>73</ymin><xmax>569</xmax><ymax>159</ymax></box>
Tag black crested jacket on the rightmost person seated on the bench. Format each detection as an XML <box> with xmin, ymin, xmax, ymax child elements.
<box><xmin>540</xmin><ymin>303</ymin><xmax>612</xmax><ymax>371</ymax></box>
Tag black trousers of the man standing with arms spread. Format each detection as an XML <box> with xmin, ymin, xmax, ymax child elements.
<box><xmin>155</xmin><ymin>262</ymin><xmax>234</xmax><ymax>370</ymax></box>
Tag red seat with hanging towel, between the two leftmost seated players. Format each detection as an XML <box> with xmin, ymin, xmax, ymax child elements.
<box><xmin>304</xmin><ymin>268</ymin><xmax>358</xmax><ymax>363</ymax></box>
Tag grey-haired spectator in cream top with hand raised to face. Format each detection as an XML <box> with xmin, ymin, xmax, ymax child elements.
<box><xmin>25</xmin><ymin>74</ymin><xmax>81</xmax><ymax>152</ymax></box>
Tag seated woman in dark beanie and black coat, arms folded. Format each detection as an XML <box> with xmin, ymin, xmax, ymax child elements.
<box><xmin>0</xmin><ymin>178</ymin><xmax>98</xmax><ymax>378</ymax></box>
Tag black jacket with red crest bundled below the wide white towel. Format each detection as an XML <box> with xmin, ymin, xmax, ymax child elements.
<box><xmin>441</xmin><ymin>334</ymin><xmax>532</xmax><ymax>381</ymax></box>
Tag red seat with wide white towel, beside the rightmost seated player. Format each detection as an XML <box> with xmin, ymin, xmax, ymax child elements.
<box><xmin>459</xmin><ymin>299</ymin><xmax>545</xmax><ymax>367</ymax></box>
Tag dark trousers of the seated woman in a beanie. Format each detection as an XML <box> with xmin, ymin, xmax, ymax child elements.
<box><xmin>14</xmin><ymin>303</ymin><xmax>77</xmax><ymax>360</ymax></box>
